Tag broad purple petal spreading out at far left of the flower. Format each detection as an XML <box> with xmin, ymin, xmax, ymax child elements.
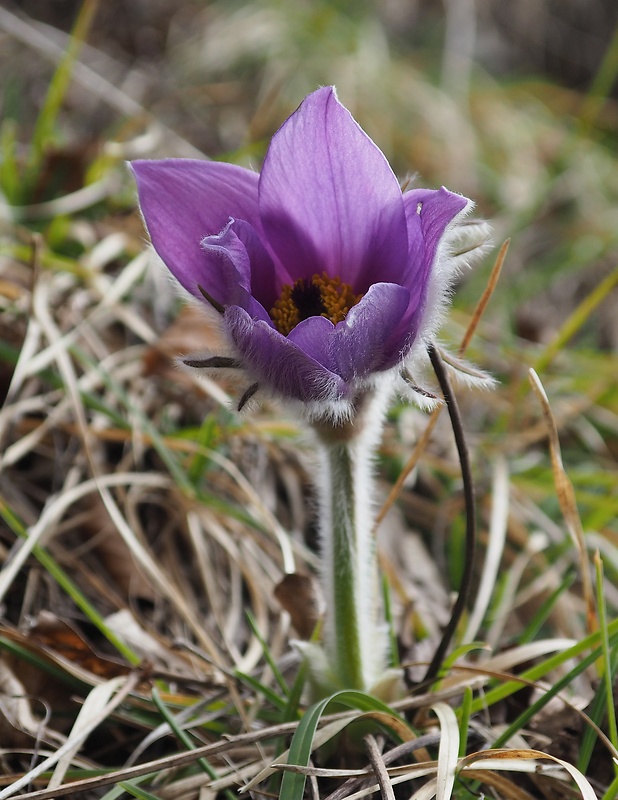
<box><xmin>131</xmin><ymin>159</ymin><xmax>260</xmax><ymax>303</ymax></box>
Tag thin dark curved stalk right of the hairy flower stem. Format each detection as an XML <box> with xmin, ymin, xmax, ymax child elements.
<box><xmin>422</xmin><ymin>345</ymin><xmax>476</xmax><ymax>684</ymax></box>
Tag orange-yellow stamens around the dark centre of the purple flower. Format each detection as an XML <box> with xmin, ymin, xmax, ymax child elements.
<box><xmin>270</xmin><ymin>272</ymin><xmax>363</xmax><ymax>336</ymax></box>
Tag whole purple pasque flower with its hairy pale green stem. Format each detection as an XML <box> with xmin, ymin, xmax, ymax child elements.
<box><xmin>132</xmin><ymin>87</ymin><xmax>483</xmax><ymax>694</ymax></box>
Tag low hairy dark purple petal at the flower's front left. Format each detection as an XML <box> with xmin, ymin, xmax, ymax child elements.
<box><xmin>224</xmin><ymin>306</ymin><xmax>347</xmax><ymax>403</ymax></box>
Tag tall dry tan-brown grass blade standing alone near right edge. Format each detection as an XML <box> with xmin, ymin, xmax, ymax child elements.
<box><xmin>528</xmin><ymin>369</ymin><xmax>598</xmax><ymax>633</ymax></box>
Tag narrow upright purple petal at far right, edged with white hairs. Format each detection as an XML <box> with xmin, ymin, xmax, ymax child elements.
<box><xmin>403</xmin><ymin>187</ymin><xmax>470</xmax><ymax>312</ymax></box>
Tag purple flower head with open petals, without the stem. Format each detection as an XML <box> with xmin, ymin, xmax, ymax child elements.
<box><xmin>132</xmin><ymin>87</ymin><xmax>469</xmax><ymax>416</ymax></box>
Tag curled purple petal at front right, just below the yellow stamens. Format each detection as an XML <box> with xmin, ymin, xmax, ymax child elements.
<box><xmin>332</xmin><ymin>283</ymin><xmax>416</xmax><ymax>381</ymax></box>
